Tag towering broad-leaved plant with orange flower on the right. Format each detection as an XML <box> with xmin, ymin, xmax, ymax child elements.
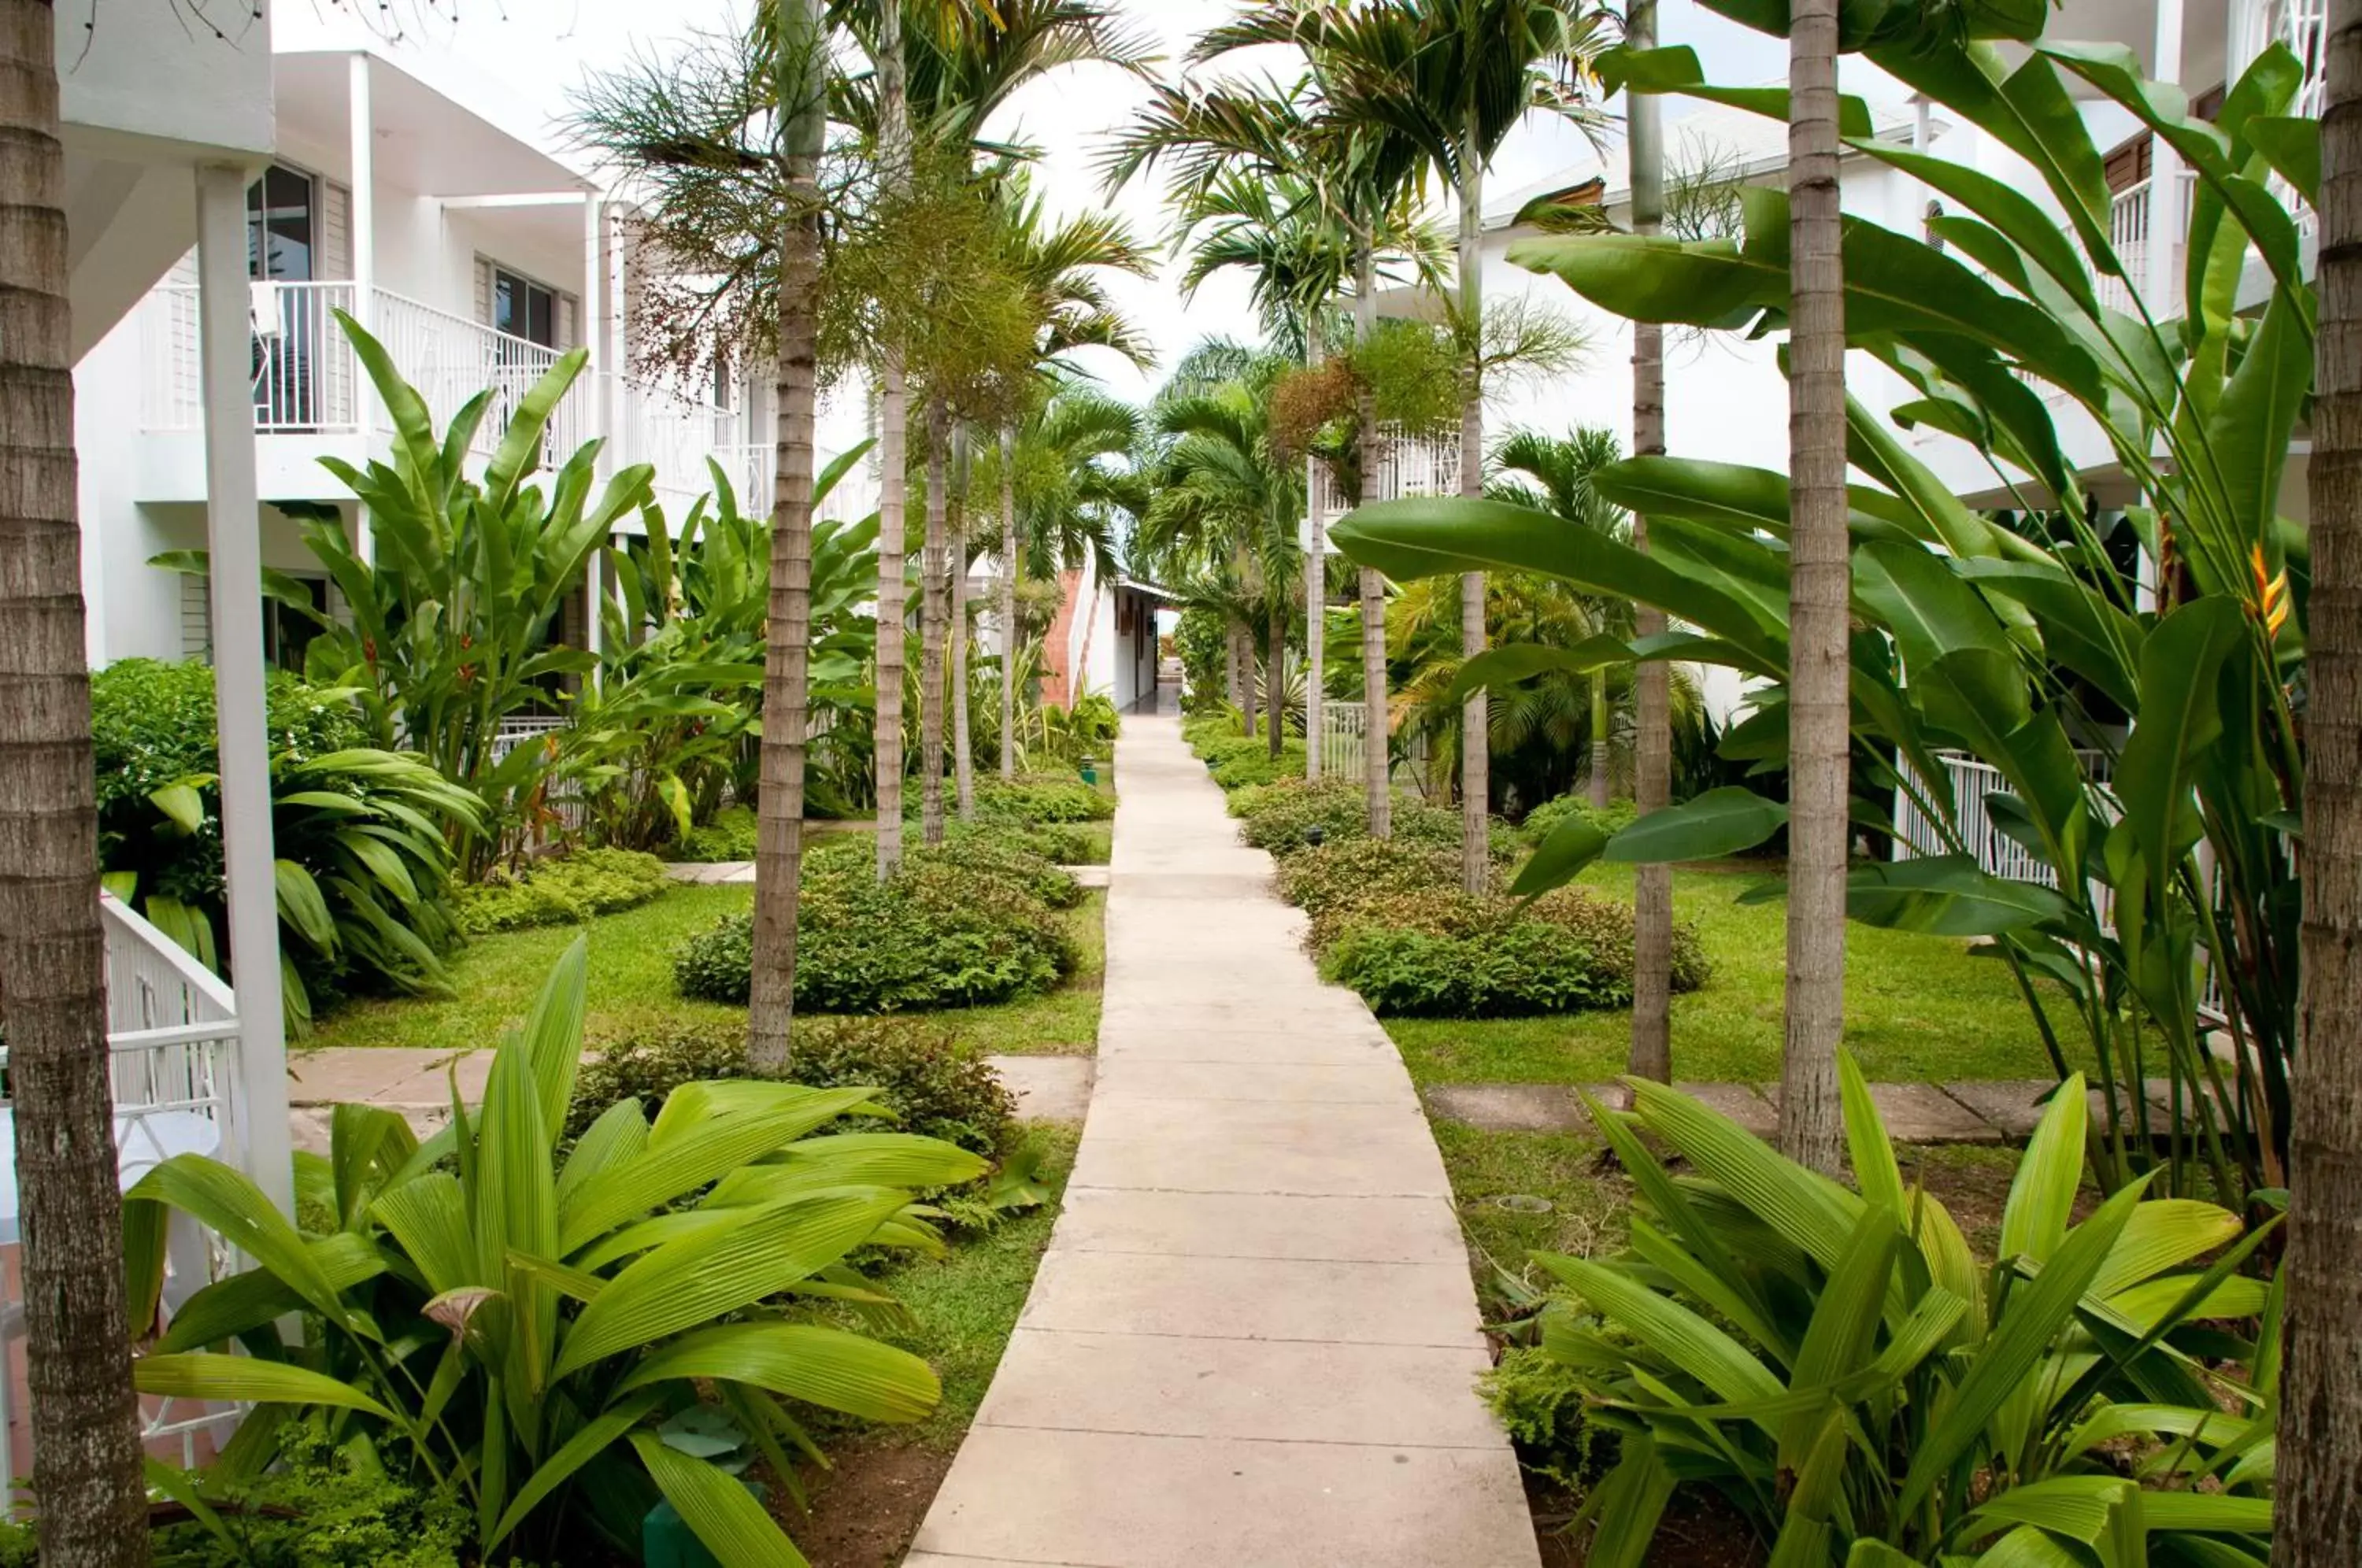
<box><xmin>1337</xmin><ymin>33</ymin><xmax>2319</xmax><ymax>1195</ymax></box>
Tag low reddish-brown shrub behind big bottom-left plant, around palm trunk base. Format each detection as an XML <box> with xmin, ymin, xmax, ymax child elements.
<box><xmin>567</xmin><ymin>1015</ymin><xmax>1016</xmax><ymax>1155</ymax></box>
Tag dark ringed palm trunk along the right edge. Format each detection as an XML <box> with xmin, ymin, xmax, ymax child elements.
<box><xmin>2277</xmin><ymin>0</ymin><xmax>2362</xmax><ymax>1568</ymax></box>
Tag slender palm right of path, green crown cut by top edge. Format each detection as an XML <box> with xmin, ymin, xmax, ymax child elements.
<box><xmin>1275</xmin><ymin>0</ymin><xmax>1609</xmax><ymax>893</ymax></box>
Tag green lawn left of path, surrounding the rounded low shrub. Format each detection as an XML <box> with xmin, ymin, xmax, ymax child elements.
<box><xmin>300</xmin><ymin>886</ymin><xmax>1108</xmax><ymax>1056</ymax></box>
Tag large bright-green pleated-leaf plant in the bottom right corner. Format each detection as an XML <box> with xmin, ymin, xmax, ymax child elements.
<box><xmin>1538</xmin><ymin>1058</ymin><xmax>2279</xmax><ymax>1568</ymax></box>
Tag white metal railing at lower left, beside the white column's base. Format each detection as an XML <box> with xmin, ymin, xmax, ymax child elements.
<box><xmin>0</xmin><ymin>895</ymin><xmax>246</xmax><ymax>1516</ymax></box>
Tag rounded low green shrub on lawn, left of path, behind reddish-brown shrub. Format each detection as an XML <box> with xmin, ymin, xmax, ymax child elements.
<box><xmin>673</xmin><ymin>855</ymin><xmax>1075</xmax><ymax>1013</ymax></box>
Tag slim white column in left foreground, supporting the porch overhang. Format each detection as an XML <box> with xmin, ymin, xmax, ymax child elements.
<box><xmin>196</xmin><ymin>163</ymin><xmax>295</xmax><ymax>1216</ymax></box>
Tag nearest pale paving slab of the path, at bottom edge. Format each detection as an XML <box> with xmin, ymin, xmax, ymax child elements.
<box><xmin>905</xmin><ymin>1426</ymin><xmax>1540</xmax><ymax>1568</ymax></box>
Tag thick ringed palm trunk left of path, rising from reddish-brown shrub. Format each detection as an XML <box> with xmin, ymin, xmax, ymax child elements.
<box><xmin>746</xmin><ymin>0</ymin><xmax>827</xmax><ymax>1077</ymax></box>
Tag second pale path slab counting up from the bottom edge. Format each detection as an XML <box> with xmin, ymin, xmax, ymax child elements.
<box><xmin>976</xmin><ymin>1327</ymin><xmax>1500</xmax><ymax>1448</ymax></box>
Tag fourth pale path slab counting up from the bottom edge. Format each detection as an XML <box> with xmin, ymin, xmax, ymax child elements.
<box><xmin>1058</xmin><ymin>1181</ymin><xmax>1462</xmax><ymax>1263</ymax></box>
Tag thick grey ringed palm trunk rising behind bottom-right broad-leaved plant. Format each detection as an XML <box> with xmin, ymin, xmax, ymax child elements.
<box><xmin>1779</xmin><ymin>0</ymin><xmax>1852</xmax><ymax>1174</ymax></box>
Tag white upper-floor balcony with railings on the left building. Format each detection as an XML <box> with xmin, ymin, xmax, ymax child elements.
<box><xmin>139</xmin><ymin>283</ymin><xmax>768</xmax><ymax>508</ymax></box>
